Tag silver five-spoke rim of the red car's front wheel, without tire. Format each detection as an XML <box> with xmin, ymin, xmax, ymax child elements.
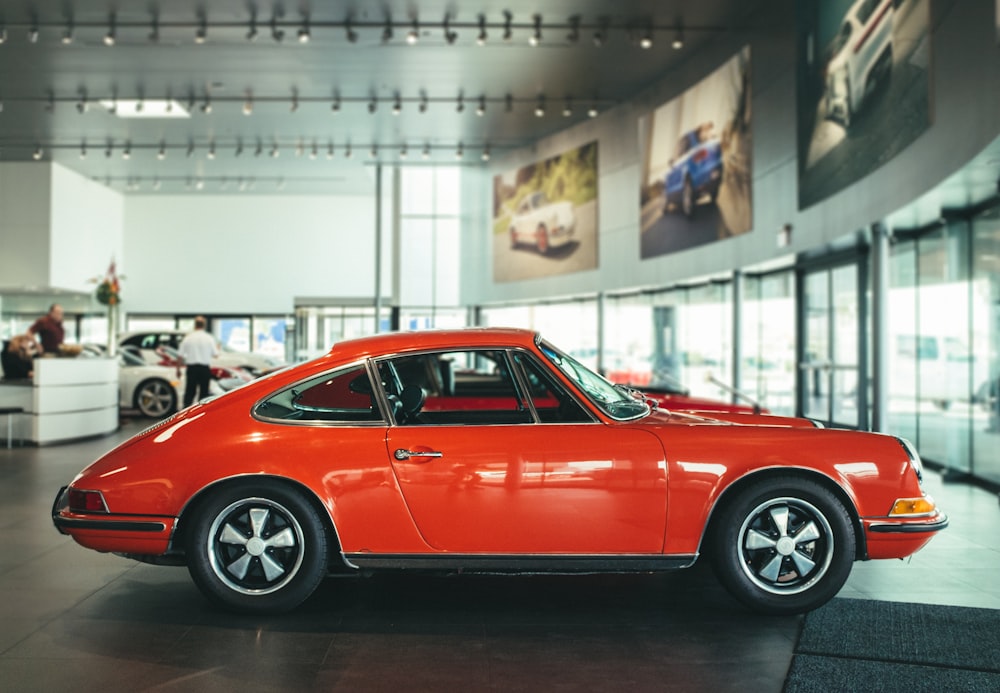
<box><xmin>737</xmin><ymin>497</ymin><xmax>835</xmax><ymax>595</ymax></box>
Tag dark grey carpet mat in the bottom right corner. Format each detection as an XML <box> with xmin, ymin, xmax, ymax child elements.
<box><xmin>784</xmin><ymin>599</ymin><xmax>1000</xmax><ymax>693</ymax></box>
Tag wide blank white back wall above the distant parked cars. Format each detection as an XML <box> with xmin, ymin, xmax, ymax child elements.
<box><xmin>123</xmin><ymin>195</ymin><xmax>375</xmax><ymax>314</ymax></box>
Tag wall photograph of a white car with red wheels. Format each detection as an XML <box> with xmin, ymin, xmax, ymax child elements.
<box><xmin>493</xmin><ymin>142</ymin><xmax>597</xmax><ymax>282</ymax></box>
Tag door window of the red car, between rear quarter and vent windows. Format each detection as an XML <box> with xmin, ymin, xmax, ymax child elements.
<box><xmin>379</xmin><ymin>350</ymin><xmax>533</xmax><ymax>426</ymax></box>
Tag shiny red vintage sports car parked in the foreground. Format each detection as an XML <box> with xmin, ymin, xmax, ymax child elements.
<box><xmin>53</xmin><ymin>329</ymin><xmax>947</xmax><ymax>613</ymax></box>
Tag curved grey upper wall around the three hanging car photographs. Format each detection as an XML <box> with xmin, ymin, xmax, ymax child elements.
<box><xmin>462</xmin><ymin>0</ymin><xmax>1000</xmax><ymax>305</ymax></box>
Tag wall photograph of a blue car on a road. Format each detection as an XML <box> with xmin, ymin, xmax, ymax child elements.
<box><xmin>639</xmin><ymin>47</ymin><xmax>753</xmax><ymax>259</ymax></box>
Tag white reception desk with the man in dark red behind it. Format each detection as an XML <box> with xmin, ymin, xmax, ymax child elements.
<box><xmin>0</xmin><ymin>357</ymin><xmax>118</xmax><ymax>445</ymax></box>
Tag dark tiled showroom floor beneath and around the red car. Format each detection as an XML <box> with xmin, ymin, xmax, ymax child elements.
<box><xmin>0</xmin><ymin>424</ymin><xmax>1000</xmax><ymax>693</ymax></box>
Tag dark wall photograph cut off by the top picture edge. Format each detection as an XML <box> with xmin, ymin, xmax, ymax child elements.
<box><xmin>796</xmin><ymin>0</ymin><xmax>931</xmax><ymax>209</ymax></box>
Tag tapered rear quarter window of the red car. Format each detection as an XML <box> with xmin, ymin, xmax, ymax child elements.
<box><xmin>253</xmin><ymin>365</ymin><xmax>383</xmax><ymax>423</ymax></box>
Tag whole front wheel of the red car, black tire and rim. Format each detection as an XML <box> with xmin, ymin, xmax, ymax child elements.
<box><xmin>710</xmin><ymin>477</ymin><xmax>856</xmax><ymax>614</ymax></box>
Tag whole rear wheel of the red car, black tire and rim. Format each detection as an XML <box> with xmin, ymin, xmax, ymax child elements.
<box><xmin>186</xmin><ymin>481</ymin><xmax>327</xmax><ymax>613</ymax></box>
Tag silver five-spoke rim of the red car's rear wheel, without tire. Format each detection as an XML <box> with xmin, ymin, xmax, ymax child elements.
<box><xmin>206</xmin><ymin>498</ymin><xmax>306</xmax><ymax>595</ymax></box>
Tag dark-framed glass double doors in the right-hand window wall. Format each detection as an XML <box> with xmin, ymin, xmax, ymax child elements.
<box><xmin>799</xmin><ymin>263</ymin><xmax>867</xmax><ymax>428</ymax></box>
